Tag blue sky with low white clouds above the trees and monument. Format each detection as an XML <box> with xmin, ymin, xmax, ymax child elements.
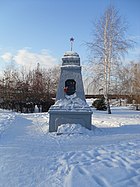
<box><xmin>0</xmin><ymin>0</ymin><xmax>140</xmax><ymax>72</ymax></box>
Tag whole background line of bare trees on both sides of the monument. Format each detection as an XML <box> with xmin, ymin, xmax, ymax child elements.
<box><xmin>0</xmin><ymin>61</ymin><xmax>140</xmax><ymax>112</ymax></box>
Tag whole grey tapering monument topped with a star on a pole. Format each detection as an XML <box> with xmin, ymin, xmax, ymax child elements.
<box><xmin>49</xmin><ymin>38</ymin><xmax>92</xmax><ymax>132</ymax></box>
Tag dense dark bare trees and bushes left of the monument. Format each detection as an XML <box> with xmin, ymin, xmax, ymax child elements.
<box><xmin>0</xmin><ymin>63</ymin><xmax>59</xmax><ymax>112</ymax></box>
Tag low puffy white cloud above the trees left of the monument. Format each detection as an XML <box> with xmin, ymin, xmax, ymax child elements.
<box><xmin>1</xmin><ymin>48</ymin><xmax>56</xmax><ymax>69</ymax></box>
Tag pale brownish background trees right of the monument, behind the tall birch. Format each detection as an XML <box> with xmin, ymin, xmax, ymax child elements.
<box><xmin>84</xmin><ymin>61</ymin><xmax>140</xmax><ymax>103</ymax></box>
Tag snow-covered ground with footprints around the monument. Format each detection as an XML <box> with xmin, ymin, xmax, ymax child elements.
<box><xmin>0</xmin><ymin>107</ymin><xmax>140</xmax><ymax>187</ymax></box>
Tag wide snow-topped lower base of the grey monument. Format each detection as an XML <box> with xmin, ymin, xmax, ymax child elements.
<box><xmin>49</xmin><ymin>93</ymin><xmax>92</xmax><ymax>132</ymax></box>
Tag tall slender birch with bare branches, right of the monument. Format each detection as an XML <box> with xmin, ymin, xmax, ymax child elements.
<box><xmin>87</xmin><ymin>6</ymin><xmax>132</xmax><ymax>114</ymax></box>
